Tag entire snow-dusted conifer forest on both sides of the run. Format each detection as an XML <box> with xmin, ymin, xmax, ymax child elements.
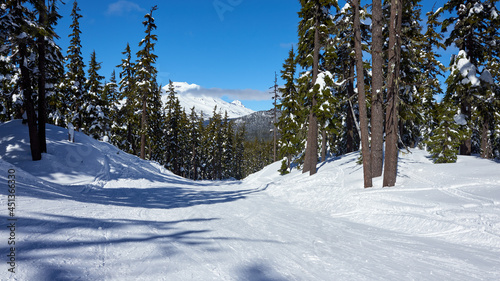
<box><xmin>0</xmin><ymin>0</ymin><xmax>500</xmax><ymax>187</ymax></box>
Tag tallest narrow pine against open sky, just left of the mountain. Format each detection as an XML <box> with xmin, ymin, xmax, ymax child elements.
<box><xmin>135</xmin><ymin>6</ymin><xmax>158</xmax><ymax>159</ymax></box>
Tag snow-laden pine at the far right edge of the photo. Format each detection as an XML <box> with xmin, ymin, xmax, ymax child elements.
<box><xmin>443</xmin><ymin>0</ymin><xmax>500</xmax><ymax>155</ymax></box>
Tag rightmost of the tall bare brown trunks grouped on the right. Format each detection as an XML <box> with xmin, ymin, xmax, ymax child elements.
<box><xmin>383</xmin><ymin>0</ymin><xmax>403</xmax><ymax>186</ymax></box>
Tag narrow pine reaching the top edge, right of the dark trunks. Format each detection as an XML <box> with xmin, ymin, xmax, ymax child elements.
<box><xmin>63</xmin><ymin>0</ymin><xmax>86</xmax><ymax>131</ymax></box>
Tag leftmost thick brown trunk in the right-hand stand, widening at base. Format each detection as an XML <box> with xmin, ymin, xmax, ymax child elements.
<box><xmin>302</xmin><ymin>5</ymin><xmax>320</xmax><ymax>176</ymax></box>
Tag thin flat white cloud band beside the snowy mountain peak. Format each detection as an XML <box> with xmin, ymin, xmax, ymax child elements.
<box><xmin>170</xmin><ymin>82</ymin><xmax>271</xmax><ymax>101</ymax></box>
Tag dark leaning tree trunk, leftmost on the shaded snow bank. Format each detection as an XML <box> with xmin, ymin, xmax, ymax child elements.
<box><xmin>19</xmin><ymin>43</ymin><xmax>42</xmax><ymax>161</ymax></box>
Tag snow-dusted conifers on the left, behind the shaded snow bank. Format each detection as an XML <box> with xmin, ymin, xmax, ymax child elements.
<box><xmin>0</xmin><ymin>0</ymin><xmax>269</xmax><ymax>179</ymax></box>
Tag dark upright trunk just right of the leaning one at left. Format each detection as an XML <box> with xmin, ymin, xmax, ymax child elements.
<box><xmin>37</xmin><ymin>0</ymin><xmax>47</xmax><ymax>153</ymax></box>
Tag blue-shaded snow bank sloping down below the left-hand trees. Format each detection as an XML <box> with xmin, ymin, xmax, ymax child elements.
<box><xmin>0</xmin><ymin>120</ymin><xmax>178</xmax><ymax>187</ymax></box>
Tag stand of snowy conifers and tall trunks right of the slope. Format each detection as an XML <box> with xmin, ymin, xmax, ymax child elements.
<box><xmin>277</xmin><ymin>0</ymin><xmax>500</xmax><ymax>187</ymax></box>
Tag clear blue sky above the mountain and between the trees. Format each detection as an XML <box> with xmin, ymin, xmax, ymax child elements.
<box><xmin>57</xmin><ymin>0</ymin><xmax>449</xmax><ymax>110</ymax></box>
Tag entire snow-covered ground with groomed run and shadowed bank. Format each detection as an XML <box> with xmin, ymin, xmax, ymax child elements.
<box><xmin>0</xmin><ymin>120</ymin><xmax>500</xmax><ymax>281</ymax></box>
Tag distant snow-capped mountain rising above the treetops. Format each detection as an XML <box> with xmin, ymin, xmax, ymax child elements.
<box><xmin>162</xmin><ymin>82</ymin><xmax>255</xmax><ymax>120</ymax></box>
